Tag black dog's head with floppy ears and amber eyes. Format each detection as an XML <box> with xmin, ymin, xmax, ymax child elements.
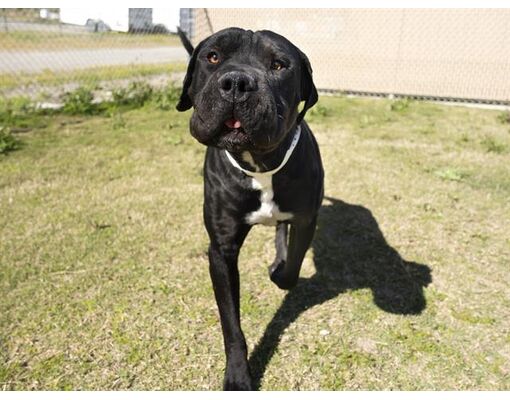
<box><xmin>177</xmin><ymin>28</ymin><xmax>318</xmax><ymax>153</ymax></box>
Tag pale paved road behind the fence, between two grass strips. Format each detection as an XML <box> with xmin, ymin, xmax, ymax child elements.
<box><xmin>0</xmin><ymin>47</ymin><xmax>188</xmax><ymax>73</ymax></box>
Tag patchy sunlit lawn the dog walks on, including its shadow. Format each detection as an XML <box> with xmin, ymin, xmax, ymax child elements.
<box><xmin>0</xmin><ymin>96</ymin><xmax>510</xmax><ymax>390</ymax></box>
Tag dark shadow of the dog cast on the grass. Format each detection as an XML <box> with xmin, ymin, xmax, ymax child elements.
<box><xmin>249</xmin><ymin>197</ymin><xmax>432</xmax><ymax>389</ymax></box>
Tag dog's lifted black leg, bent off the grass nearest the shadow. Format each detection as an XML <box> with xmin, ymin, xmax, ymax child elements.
<box><xmin>269</xmin><ymin>217</ymin><xmax>317</xmax><ymax>290</ymax></box>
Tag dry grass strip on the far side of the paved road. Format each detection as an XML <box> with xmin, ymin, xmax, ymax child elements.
<box><xmin>0</xmin><ymin>31</ymin><xmax>181</xmax><ymax>51</ymax></box>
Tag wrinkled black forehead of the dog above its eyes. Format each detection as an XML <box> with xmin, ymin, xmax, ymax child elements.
<box><xmin>204</xmin><ymin>28</ymin><xmax>298</xmax><ymax>57</ymax></box>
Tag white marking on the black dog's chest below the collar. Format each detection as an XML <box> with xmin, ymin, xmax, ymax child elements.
<box><xmin>246</xmin><ymin>175</ymin><xmax>292</xmax><ymax>225</ymax></box>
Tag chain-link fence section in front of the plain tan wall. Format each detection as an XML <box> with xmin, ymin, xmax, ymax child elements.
<box><xmin>190</xmin><ymin>8</ymin><xmax>510</xmax><ymax>104</ymax></box>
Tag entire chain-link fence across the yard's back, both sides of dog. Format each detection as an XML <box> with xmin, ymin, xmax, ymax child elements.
<box><xmin>0</xmin><ymin>8</ymin><xmax>510</xmax><ymax>104</ymax></box>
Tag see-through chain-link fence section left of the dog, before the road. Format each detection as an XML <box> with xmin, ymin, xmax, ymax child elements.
<box><xmin>0</xmin><ymin>8</ymin><xmax>187</xmax><ymax>102</ymax></box>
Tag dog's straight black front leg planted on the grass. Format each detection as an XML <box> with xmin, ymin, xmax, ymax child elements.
<box><xmin>209</xmin><ymin>231</ymin><xmax>252</xmax><ymax>390</ymax></box>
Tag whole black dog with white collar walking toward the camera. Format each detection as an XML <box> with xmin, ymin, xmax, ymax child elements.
<box><xmin>177</xmin><ymin>28</ymin><xmax>324</xmax><ymax>390</ymax></box>
